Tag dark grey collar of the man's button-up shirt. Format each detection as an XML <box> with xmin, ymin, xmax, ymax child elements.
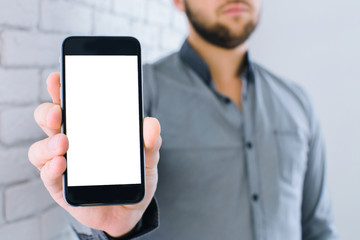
<box><xmin>180</xmin><ymin>40</ymin><xmax>255</xmax><ymax>85</ymax></box>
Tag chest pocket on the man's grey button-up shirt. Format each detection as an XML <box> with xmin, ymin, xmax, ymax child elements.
<box><xmin>274</xmin><ymin>129</ymin><xmax>308</xmax><ymax>186</ymax></box>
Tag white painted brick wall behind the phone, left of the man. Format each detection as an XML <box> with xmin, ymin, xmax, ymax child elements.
<box><xmin>0</xmin><ymin>0</ymin><xmax>187</xmax><ymax>240</ymax></box>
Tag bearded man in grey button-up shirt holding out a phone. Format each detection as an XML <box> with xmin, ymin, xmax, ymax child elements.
<box><xmin>29</xmin><ymin>0</ymin><xmax>337</xmax><ymax>240</ymax></box>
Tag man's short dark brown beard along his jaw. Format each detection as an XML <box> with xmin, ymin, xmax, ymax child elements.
<box><xmin>184</xmin><ymin>0</ymin><xmax>258</xmax><ymax>49</ymax></box>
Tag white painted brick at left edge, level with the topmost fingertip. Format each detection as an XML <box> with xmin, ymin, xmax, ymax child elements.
<box><xmin>0</xmin><ymin>69</ymin><xmax>40</xmax><ymax>103</ymax></box>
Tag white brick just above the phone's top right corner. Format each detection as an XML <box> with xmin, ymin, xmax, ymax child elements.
<box><xmin>131</xmin><ymin>22</ymin><xmax>160</xmax><ymax>48</ymax></box>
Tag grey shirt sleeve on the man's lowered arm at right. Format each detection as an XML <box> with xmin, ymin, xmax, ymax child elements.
<box><xmin>302</xmin><ymin>102</ymin><xmax>338</xmax><ymax>240</ymax></box>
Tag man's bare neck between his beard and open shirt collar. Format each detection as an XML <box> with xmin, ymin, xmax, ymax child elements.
<box><xmin>188</xmin><ymin>29</ymin><xmax>248</xmax><ymax>85</ymax></box>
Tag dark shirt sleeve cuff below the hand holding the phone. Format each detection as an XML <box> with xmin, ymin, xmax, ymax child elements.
<box><xmin>73</xmin><ymin>198</ymin><xmax>159</xmax><ymax>240</ymax></box>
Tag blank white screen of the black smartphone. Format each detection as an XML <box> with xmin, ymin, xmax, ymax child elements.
<box><xmin>65</xmin><ymin>55</ymin><xmax>141</xmax><ymax>186</ymax></box>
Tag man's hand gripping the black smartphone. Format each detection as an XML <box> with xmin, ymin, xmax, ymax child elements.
<box><xmin>28</xmin><ymin>73</ymin><xmax>161</xmax><ymax>236</ymax></box>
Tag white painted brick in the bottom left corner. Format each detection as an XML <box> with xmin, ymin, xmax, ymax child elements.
<box><xmin>0</xmin><ymin>218</ymin><xmax>40</xmax><ymax>240</ymax></box>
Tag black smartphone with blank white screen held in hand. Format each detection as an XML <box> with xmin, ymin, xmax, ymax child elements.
<box><xmin>61</xmin><ymin>36</ymin><xmax>145</xmax><ymax>206</ymax></box>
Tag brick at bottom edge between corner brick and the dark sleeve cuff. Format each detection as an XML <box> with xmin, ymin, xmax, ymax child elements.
<box><xmin>41</xmin><ymin>206</ymin><xmax>70</xmax><ymax>239</ymax></box>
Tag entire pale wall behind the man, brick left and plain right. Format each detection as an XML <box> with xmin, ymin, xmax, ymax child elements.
<box><xmin>0</xmin><ymin>0</ymin><xmax>360</xmax><ymax>240</ymax></box>
